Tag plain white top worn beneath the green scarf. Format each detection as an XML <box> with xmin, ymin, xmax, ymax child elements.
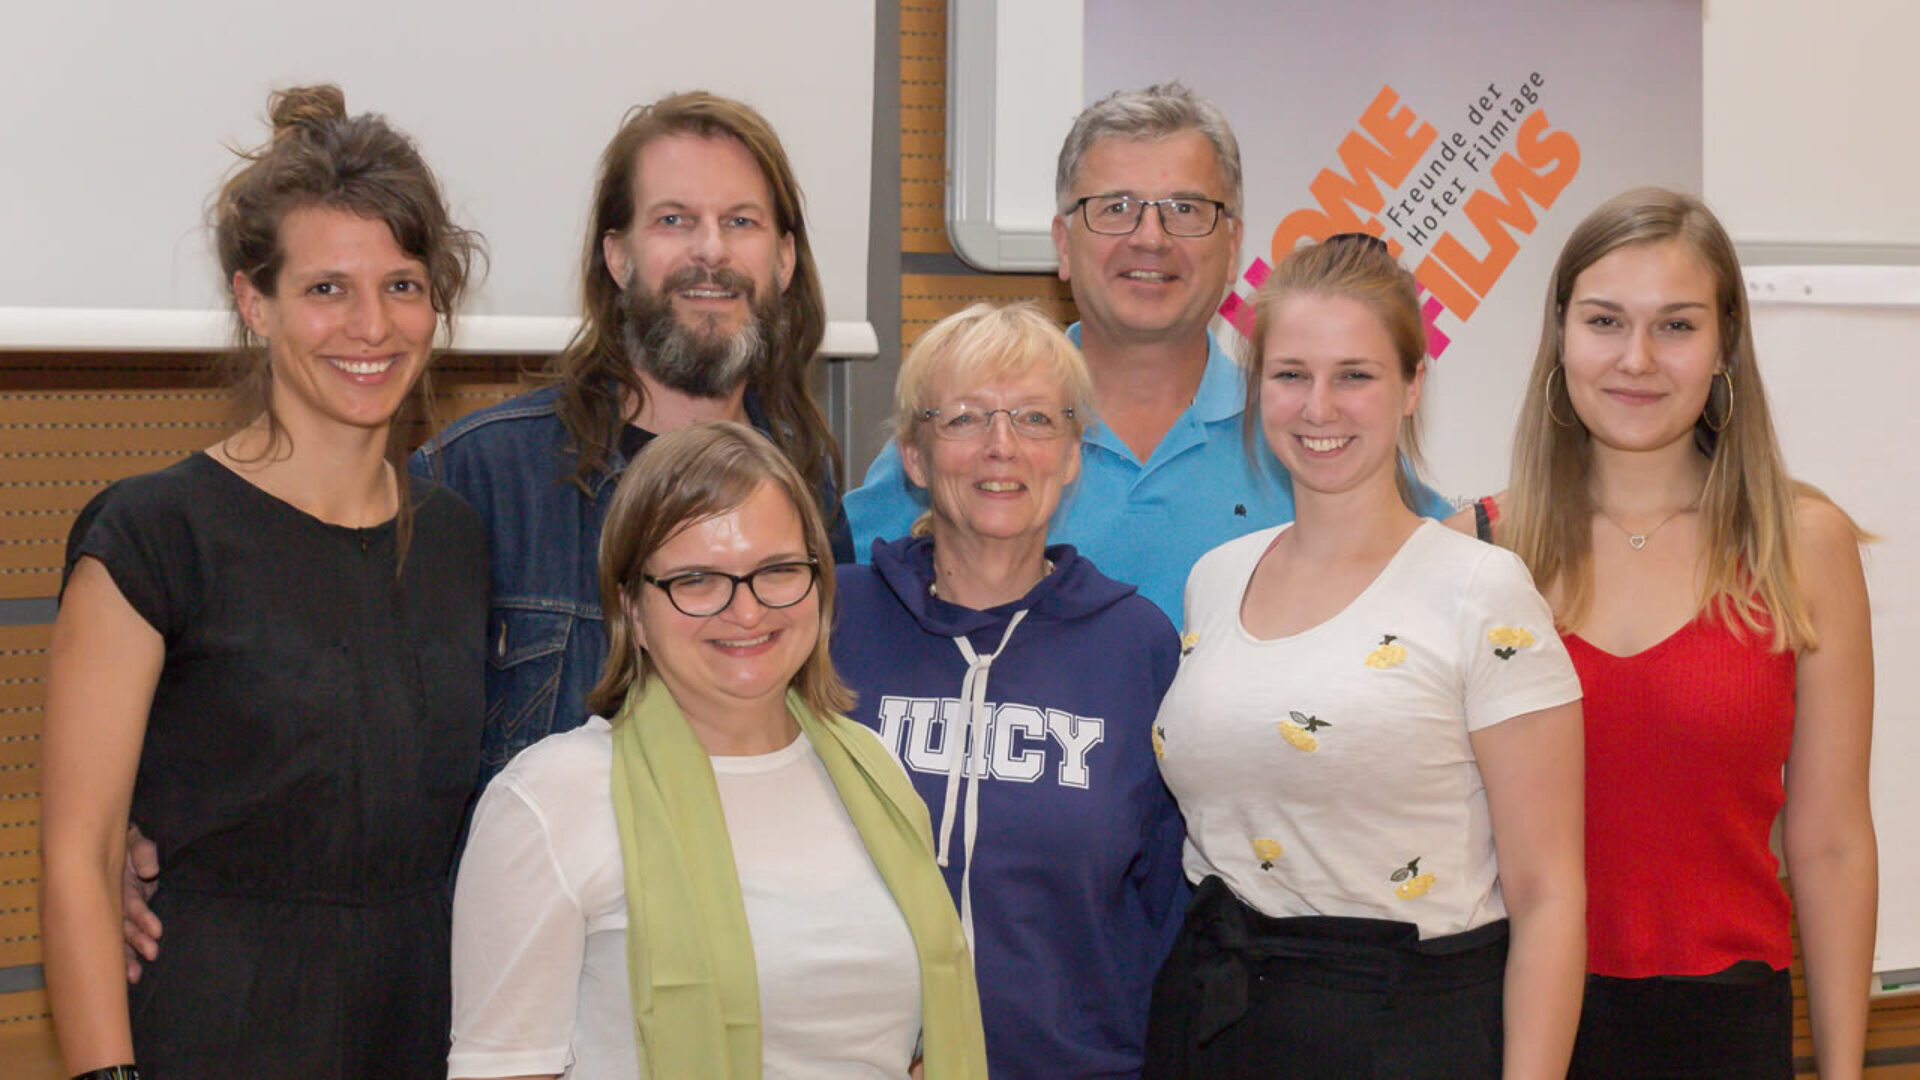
<box><xmin>447</xmin><ymin>717</ymin><xmax>920</xmax><ymax>1080</ymax></box>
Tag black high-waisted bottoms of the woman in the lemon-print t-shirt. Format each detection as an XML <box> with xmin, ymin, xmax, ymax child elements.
<box><xmin>1142</xmin><ymin>876</ymin><xmax>1507</xmax><ymax>1080</ymax></box>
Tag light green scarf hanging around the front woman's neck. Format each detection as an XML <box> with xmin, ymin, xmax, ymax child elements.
<box><xmin>612</xmin><ymin>676</ymin><xmax>987</xmax><ymax>1080</ymax></box>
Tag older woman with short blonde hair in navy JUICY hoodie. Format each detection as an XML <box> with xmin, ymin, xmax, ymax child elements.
<box><xmin>833</xmin><ymin>304</ymin><xmax>1187</xmax><ymax>1080</ymax></box>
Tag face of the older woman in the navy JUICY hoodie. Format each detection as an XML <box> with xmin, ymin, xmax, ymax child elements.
<box><xmin>900</xmin><ymin>365</ymin><xmax>1079</xmax><ymax>546</ymax></box>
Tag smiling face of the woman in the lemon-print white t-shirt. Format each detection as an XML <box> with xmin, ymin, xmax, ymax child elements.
<box><xmin>1260</xmin><ymin>292</ymin><xmax>1427</xmax><ymax>498</ymax></box>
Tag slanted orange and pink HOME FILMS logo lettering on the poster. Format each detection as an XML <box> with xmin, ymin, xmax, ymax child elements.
<box><xmin>1219</xmin><ymin>71</ymin><xmax>1580</xmax><ymax>357</ymax></box>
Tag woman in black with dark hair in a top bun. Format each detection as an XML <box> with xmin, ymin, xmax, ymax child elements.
<box><xmin>42</xmin><ymin>86</ymin><xmax>488</xmax><ymax>1078</ymax></box>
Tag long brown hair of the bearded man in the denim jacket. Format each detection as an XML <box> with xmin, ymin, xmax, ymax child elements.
<box><xmin>549</xmin><ymin>90</ymin><xmax>839</xmax><ymax>492</ymax></box>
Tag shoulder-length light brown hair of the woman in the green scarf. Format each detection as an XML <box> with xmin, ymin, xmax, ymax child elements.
<box><xmin>588</xmin><ymin>421</ymin><xmax>854</xmax><ymax>717</ymax></box>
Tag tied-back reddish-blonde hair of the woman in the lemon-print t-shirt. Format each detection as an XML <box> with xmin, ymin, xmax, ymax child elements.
<box><xmin>1240</xmin><ymin>233</ymin><xmax>1427</xmax><ymax>513</ymax></box>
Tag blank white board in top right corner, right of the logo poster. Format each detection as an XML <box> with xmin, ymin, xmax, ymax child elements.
<box><xmin>1703</xmin><ymin>0</ymin><xmax>1920</xmax><ymax>249</ymax></box>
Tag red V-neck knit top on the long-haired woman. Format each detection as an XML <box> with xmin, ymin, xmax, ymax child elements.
<box><xmin>1565</xmin><ymin>617</ymin><xmax>1795</xmax><ymax>978</ymax></box>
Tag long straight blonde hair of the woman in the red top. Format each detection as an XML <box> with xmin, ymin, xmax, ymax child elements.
<box><xmin>1500</xmin><ymin>188</ymin><xmax>1826</xmax><ymax>651</ymax></box>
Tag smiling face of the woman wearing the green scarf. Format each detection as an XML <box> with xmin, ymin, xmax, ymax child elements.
<box><xmin>628</xmin><ymin>482</ymin><xmax>820</xmax><ymax>726</ymax></box>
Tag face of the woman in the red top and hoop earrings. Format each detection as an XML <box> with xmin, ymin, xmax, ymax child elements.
<box><xmin>1561</xmin><ymin>240</ymin><xmax>1722</xmax><ymax>452</ymax></box>
